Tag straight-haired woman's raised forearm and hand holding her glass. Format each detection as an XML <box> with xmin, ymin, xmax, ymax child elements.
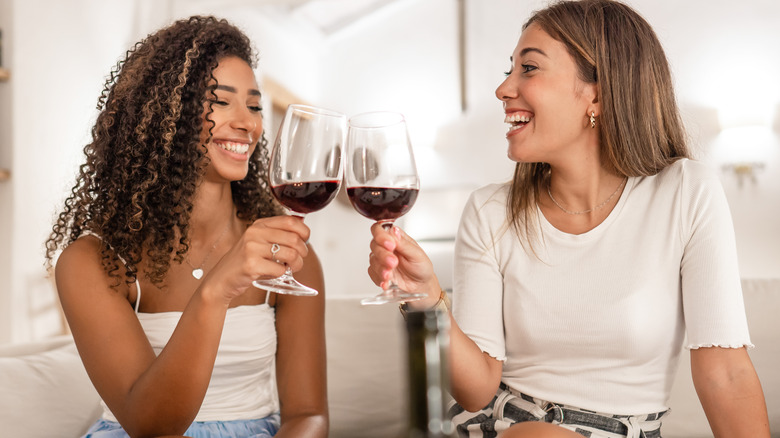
<box><xmin>369</xmin><ymin>224</ymin><xmax>503</xmax><ymax>412</ymax></box>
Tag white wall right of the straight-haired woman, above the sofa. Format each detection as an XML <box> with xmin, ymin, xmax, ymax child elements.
<box><xmin>632</xmin><ymin>0</ymin><xmax>780</xmax><ymax>278</ymax></box>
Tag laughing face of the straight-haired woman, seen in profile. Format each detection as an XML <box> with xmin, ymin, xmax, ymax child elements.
<box><xmin>496</xmin><ymin>24</ymin><xmax>600</xmax><ymax>164</ymax></box>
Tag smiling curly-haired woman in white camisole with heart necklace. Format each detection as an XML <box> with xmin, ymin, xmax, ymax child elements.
<box><xmin>47</xmin><ymin>17</ymin><xmax>328</xmax><ymax>437</ymax></box>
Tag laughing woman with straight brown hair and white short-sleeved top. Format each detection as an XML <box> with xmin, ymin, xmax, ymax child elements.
<box><xmin>369</xmin><ymin>0</ymin><xmax>769</xmax><ymax>438</ymax></box>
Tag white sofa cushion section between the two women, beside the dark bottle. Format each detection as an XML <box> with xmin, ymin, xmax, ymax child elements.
<box><xmin>325</xmin><ymin>298</ymin><xmax>408</xmax><ymax>438</ymax></box>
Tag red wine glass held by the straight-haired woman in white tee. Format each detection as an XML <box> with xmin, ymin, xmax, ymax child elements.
<box><xmin>346</xmin><ymin>111</ymin><xmax>426</xmax><ymax>304</ymax></box>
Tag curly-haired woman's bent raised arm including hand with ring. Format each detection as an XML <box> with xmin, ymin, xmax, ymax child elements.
<box><xmin>56</xmin><ymin>217</ymin><xmax>308</xmax><ymax>437</ymax></box>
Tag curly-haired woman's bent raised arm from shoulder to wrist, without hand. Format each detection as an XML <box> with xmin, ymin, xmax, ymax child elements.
<box><xmin>56</xmin><ymin>238</ymin><xmax>224</xmax><ymax>436</ymax></box>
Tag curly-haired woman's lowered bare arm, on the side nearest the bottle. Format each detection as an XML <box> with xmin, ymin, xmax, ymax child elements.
<box><xmin>276</xmin><ymin>251</ymin><xmax>328</xmax><ymax>438</ymax></box>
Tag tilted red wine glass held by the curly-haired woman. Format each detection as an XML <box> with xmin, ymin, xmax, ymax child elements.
<box><xmin>252</xmin><ymin>104</ymin><xmax>347</xmax><ymax>296</ymax></box>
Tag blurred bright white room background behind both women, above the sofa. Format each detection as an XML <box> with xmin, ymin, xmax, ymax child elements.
<box><xmin>0</xmin><ymin>0</ymin><xmax>780</xmax><ymax>344</ymax></box>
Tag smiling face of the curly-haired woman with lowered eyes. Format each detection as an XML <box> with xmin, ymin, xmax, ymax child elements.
<box><xmin>201</xmin><ymin>56</ymin><xmax>263</xmax><ymax>182</ymax></box>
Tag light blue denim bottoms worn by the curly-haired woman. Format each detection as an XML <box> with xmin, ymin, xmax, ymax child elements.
<box><xmin>83</xmin><ymin>413</ymin><xmax>281</xmax><ymax>438</ymax></box>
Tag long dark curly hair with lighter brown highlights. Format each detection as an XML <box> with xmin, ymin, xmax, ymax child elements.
<box><xmin>46</xmin><ymin>16</ymin><xmax>281</xmax><ymax>285</ymax></box>
